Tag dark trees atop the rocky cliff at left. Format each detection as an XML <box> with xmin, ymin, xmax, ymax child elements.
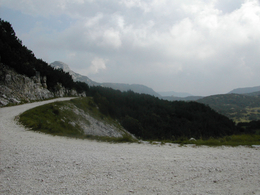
<box><xmin>0</xmin><ymin>19</ymin><xmax>89</xmax><ymax>92</ymax></box>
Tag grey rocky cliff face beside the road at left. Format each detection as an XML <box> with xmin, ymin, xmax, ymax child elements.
<box><xmin>0</xmin><ymin>64</ymin><xmax>85</xmax><ymax>107</ymax></box>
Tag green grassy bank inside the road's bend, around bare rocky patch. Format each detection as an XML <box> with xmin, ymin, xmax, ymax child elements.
<box><xmin>19</xmin><ymin>98</ymin><xmax>135</xmax><ymax>142</ymax></box>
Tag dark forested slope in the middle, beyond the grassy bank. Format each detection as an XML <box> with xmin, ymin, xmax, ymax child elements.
<box><xmin>89</xmin><ymin>87</ymin><xmax>238</xmax><ymax>140</ymax></box>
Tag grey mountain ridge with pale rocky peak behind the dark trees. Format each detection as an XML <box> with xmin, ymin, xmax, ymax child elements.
<box><xmin>50</xmin><ymin>61</ymin><xmax>161</xmax><ymax>97</ymax></box>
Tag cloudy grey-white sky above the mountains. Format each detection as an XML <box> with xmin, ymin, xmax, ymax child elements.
<box><xmin>0</xmin><ymin>0</ymin><xmax>260</xmax><ymax>96</ymax></box>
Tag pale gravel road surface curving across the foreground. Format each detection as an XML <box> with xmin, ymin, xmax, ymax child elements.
<box><xmin>0</xmin><ymin>98</ymin><xmax>260</xmax><ymax>195</ymax></box>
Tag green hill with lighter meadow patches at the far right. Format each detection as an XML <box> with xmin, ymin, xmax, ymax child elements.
<box><xmin>197</xmin><ymin>94</ymin><xmax>260</xmax><ymax>122</ymax></box>
